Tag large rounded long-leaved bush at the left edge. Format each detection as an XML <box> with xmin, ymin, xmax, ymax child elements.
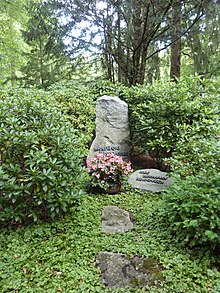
<box><xmin>0</xmin><ymin>90</ymin><xmax>85</xmax><ymax>223</ymax></box>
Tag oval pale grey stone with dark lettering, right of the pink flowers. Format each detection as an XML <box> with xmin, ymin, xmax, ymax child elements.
<box><xmin>128</xmin><ymin>169</ymin><xmax>173</xmax><ymax>192</ymax></box>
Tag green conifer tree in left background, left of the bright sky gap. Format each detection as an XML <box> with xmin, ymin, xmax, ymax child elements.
<box><xmin>23</xmin><ymin>2</ymin><xmax>71</xmax><ymax>87</ymax></box>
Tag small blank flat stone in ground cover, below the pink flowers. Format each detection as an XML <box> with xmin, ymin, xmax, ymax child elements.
<box><xmin>101</xmin><ymin>206</ymin><xmax>133</xmax><ymax>234</ymax></box>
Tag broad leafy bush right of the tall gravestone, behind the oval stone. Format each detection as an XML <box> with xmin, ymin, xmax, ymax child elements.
<box><xmin>124</xmin><ymin>77</ymin><xmax>220</xmax><ymax>167</ymax></box>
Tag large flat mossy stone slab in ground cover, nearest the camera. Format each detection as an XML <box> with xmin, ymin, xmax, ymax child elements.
<box><xmin>97</xmin><ymin>251</ymin><xmax>164</xmax><ymax>288</ymax></box>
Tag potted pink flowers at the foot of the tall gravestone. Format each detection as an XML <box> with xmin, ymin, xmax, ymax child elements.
<box><xmin>87</xmin><ymin>153</ymin><xmax>133</xmax><ymax>193</ymax></box>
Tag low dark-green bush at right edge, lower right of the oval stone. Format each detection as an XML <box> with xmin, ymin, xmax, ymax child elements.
<box><xmin>160</xmin><ymin>170</ymin><xmax>220</xmax><ymax>249</ymax></box>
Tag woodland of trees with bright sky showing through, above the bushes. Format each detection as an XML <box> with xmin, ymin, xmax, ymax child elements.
<box><xmin>0</xmin><ymin>0</ymin><xmax>220</xmax><ymax>88</ymax></box>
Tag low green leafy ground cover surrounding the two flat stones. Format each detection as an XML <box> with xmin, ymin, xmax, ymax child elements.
<box><xmin>0</xmin><ymin>188</ymin><xmax>220</xmax><ymax>293</ymax></box>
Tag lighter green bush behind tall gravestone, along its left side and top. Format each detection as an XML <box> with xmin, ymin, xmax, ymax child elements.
<box><xmin>46</xmin><ymin>81</ymin><xmax>127</xmax><ymax>149</ymax></box>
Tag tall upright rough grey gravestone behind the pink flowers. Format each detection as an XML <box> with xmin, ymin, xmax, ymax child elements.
<box><xmin>87</xmin><ymin>96</ymin><xmax>130</xmax><ymax>161</ymax></box>
